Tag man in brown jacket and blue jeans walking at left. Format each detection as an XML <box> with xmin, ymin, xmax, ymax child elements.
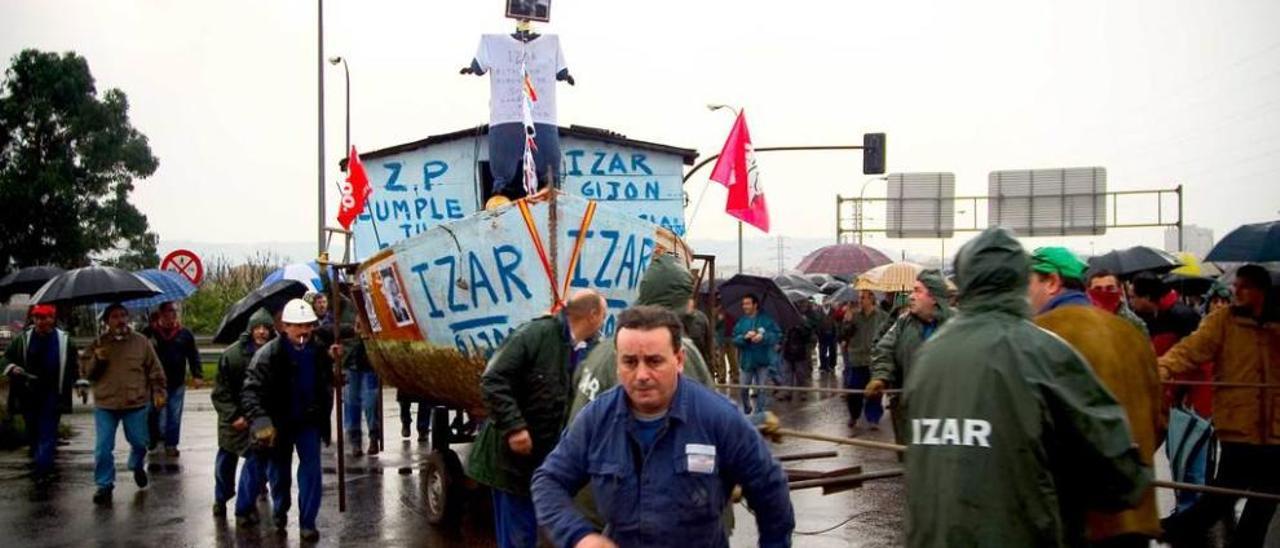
<box><xmin>78</xmin><ymin>303</ymin><xmax>165</xmax><ymax>506</ymax></box>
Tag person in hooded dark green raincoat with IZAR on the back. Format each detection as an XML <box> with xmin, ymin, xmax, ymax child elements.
<box><xmin>901</xmin><ymin>228</ymin><xmax>1152</xmax><ymax>547</ymax></box>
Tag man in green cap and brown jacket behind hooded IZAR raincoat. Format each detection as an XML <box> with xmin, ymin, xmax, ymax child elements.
<box><xmin>1028</xmin><ymin>247</ymin><xmax>1165</xmax><ymax>547</ymax></box>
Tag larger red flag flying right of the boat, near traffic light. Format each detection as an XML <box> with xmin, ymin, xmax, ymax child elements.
<box><xmin>710</xmin><ymin>113</ymin><xmax>769</xmax><ymax>232</ymax></box>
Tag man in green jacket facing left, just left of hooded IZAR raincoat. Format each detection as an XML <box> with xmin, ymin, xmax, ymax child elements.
<box><xmin>865</xmin><ymin>269</ymin><xmax>951</xmax><ymax>444</ymax></box>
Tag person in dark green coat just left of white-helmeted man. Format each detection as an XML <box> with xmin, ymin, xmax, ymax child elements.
<box><xmin>210</xmin><ymin>310</ymin><xmax>275</xmax><ymax>517</ymax></box>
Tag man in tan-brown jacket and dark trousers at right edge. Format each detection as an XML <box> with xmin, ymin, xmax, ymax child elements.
<box><xmin>1160</xmin><ymin>265</ymin><xmax>1280</xmax><ymax>547</ymax></box>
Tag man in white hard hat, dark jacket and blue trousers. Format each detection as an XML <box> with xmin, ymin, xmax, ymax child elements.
<box><xmin>236</xmin><ymin>298</ymin><xmax>340</xmax><ymax>542</ymax></box>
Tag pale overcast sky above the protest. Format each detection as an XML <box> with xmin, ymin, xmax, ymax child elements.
<box><xmin>0</xmin><ymin>0</ymin><xmax>1280</xmax><ymax>259</ymax></box>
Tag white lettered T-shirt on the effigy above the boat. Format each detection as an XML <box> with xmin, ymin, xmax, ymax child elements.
<box><xmin>475</xmin><ymin>35</ymin><xmax>567</xmax><ymax>125</ymax></box>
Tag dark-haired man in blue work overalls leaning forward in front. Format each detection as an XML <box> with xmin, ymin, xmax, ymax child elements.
<box><xmin>532</xmin><ymin>306</ymin><xmax>795</xmax><ymax>547</ymax></box>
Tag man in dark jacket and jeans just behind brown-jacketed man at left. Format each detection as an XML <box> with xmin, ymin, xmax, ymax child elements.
<box><xmin>146</xmin><ymin>302</ymin><xmax>205</xmax><ymax>457</ymax></box>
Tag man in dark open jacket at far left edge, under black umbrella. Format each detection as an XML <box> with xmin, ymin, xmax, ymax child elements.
<box><xmin>4</xmin><ymin>305</ymin><xmax>79</xmax><ymax>484</ymax></box>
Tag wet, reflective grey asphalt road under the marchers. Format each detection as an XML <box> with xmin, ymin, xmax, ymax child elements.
<box><xmin>0</xmin><ymin>373</ymin><xmax>904</xmax><ymax>548</ymax></box>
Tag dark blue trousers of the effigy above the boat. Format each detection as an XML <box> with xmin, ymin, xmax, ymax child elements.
<box><xmin>489</xmin><ymin>123</ymin><xmax>558</xmax><ymax>197</ymax></box>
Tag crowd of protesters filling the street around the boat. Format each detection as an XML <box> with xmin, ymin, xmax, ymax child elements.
<box><xmin>4</xmin><ymin>236</ymin><xmax>1280</xmax><ymax>547</ymax></box>
